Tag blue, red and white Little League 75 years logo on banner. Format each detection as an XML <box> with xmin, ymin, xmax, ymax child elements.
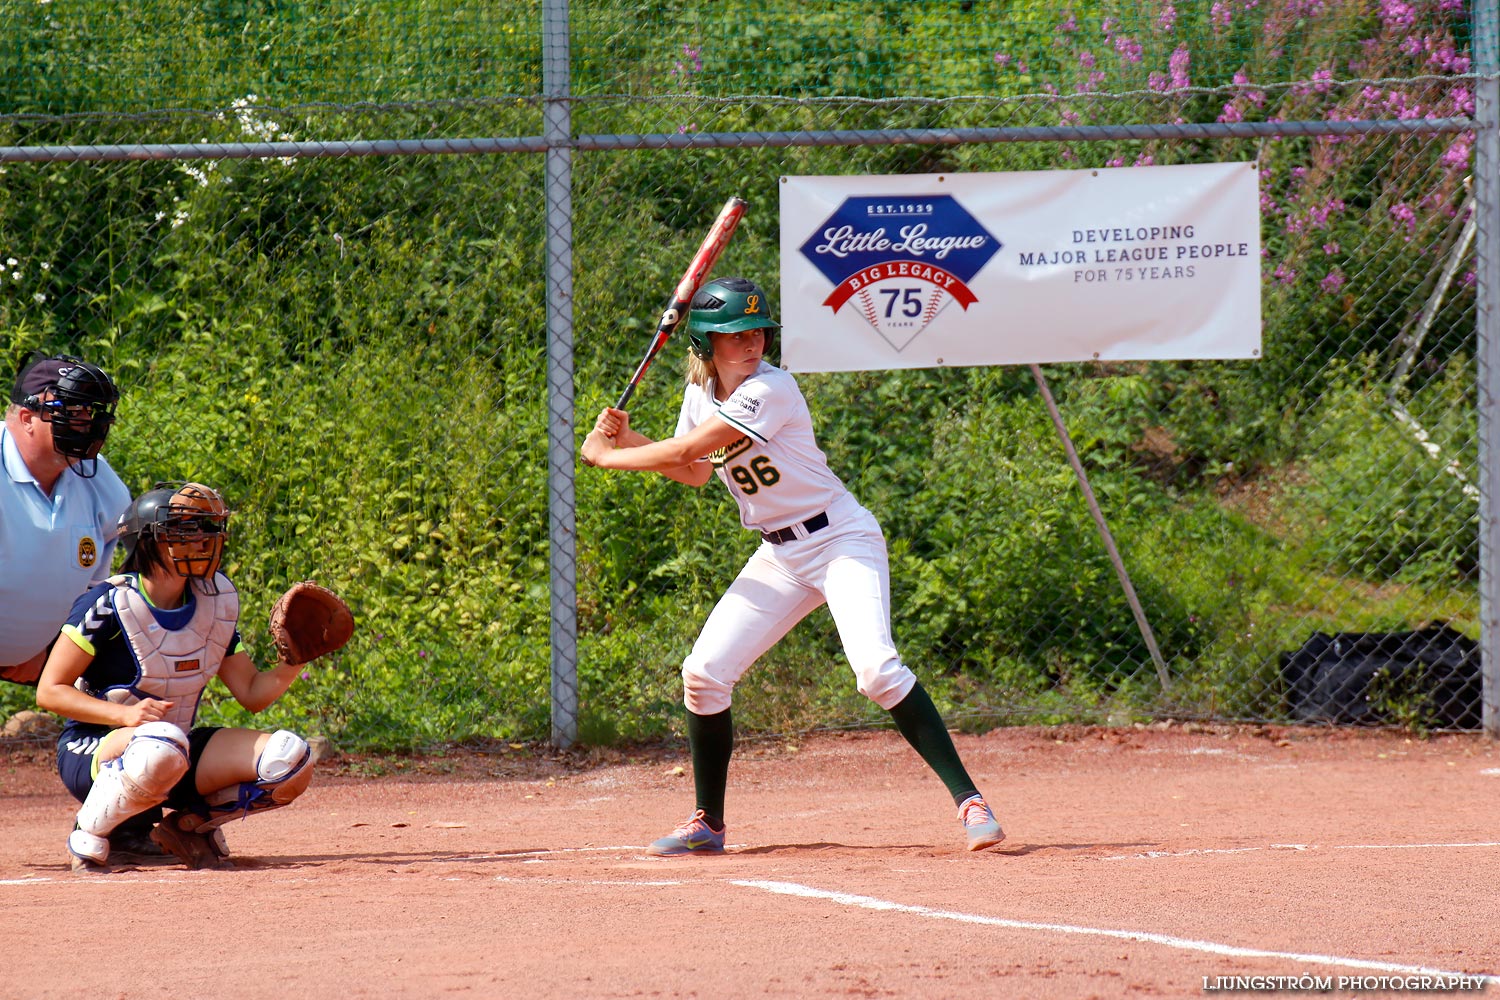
<box><xmin>801</xmin><ymin>195</ymin><xmax>1002</xmax><ymax>351</ymax></box>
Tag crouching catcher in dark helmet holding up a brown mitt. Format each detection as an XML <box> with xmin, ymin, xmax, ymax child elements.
<box><xmin>36</xmin><ymin>483</ymin><xmax>354</xmax><ymax>871</ymax></box>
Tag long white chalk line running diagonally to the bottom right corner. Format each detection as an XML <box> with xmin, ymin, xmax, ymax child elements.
<box><xmin>731</xmin><ymin>879</ymin><xmax>1500</xmax><ymax>984</ymax></box>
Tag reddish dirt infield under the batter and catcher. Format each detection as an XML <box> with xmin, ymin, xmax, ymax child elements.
<box><xmin>0</xmin><ymin>726</ymin><xmax>1500</xmax><ymax>1000</ymax></box>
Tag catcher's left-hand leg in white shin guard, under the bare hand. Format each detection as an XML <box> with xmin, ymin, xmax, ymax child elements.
<box><xmin>68</xmin><ymin>723</ymin><xmax>188</xmax><ymax>868</ymax></box>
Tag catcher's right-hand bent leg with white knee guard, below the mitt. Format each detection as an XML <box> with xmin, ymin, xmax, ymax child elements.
<box><xmin>153</xmin><ymin>729</ymin><xmax>312</xmax><ymax>868</ymax></box>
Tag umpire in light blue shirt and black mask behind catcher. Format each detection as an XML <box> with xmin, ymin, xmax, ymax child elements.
<box><xmin>0</xmin><ymin>352</ymin><xmax>131</xmax><ymax>685</ymax></box>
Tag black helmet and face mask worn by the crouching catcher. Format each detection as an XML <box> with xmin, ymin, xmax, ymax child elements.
<box><xmin>117</xmin><ymin>483</ymin><xmax>231</xmax><ymax>594</ymax></box>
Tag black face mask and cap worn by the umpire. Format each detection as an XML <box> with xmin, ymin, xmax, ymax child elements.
<box><xmin>11</xmin><ymin>354</ymin><xmax>120</xmax><ymax>480</ymax></box>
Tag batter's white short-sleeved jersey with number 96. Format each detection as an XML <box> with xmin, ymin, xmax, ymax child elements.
<box><xmin>677</xmin><ymin>361</ymin><xmax>849</xmax><ymax>532</ymax></box>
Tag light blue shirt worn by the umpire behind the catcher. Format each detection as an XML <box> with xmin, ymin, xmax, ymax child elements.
<box><xmin>0</xmin><ymin>426</ymin><xmax>131</xmax><ymax>666</ymax></box>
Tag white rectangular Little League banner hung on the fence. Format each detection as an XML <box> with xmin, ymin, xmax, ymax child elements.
<box><xmin>780</xmin><ymin>163</ymin><xmax>1260</xmax><ymax>372</ymax></box>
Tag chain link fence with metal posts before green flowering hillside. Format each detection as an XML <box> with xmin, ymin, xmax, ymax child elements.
<box><xmin>0</xmin><ymin>0</ymin><xmax>1496</xmax><ymax>748</ymax></box>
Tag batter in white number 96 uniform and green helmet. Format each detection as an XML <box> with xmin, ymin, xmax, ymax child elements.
<box><xmin>582</xmin><ymin>277</ymin><xmax>1005</xmax><ymax>856</ymax></box>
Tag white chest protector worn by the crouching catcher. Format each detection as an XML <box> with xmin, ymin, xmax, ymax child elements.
<box><xmin>104</xmin><ymin>573</ymin><xmax>240</xmax><ymax>732</ymax></box>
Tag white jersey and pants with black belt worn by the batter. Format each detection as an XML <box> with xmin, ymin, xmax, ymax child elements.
<box><xmin>677</xmin><ymin>361</ymin><xmax>917</xmax><ymax>715</ymax></box>
